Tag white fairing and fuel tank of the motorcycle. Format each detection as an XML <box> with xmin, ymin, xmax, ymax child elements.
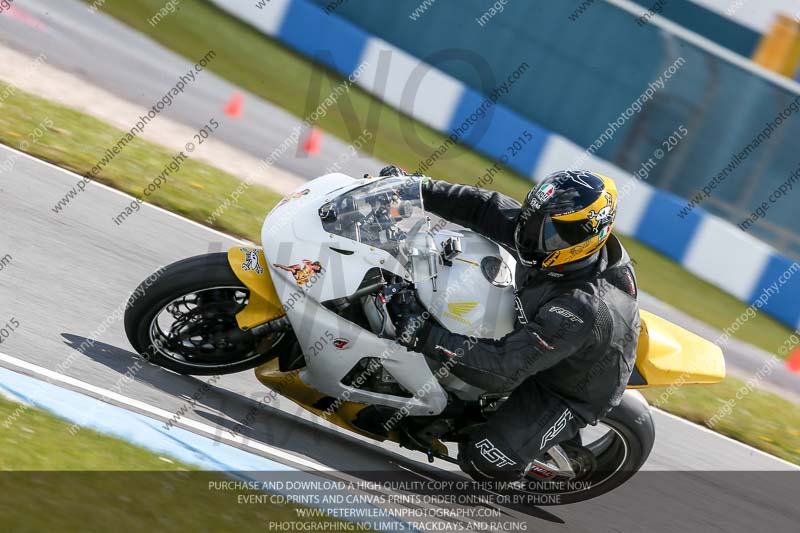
<box><xmin>261</xmin><ymin>173</ymin><xmax>514</xmax><ymax>415</ymax></box>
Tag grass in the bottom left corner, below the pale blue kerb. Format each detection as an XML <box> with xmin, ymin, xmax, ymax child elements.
<box><xmin>0</xmin><ymin>397</ymin><xmax>354</xmax><ymax>533</ymax></box>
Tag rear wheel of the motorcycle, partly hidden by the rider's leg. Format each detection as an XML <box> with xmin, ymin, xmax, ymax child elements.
<box><xmin>523</xmin><ymin>391</ymin><xmax>655</xmax><ymax>505</ymax></box>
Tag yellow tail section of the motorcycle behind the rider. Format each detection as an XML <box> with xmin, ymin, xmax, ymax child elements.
<box><xmin>629</xmin><ymin>311</ymin><xmax>725</xmax><ymax>388</ymax></box>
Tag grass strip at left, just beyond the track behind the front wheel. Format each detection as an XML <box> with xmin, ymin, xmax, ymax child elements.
<box><xmin>0</xmin><ymin>81</ymin><xmax>281</xmax><ymax>240</ymax></box>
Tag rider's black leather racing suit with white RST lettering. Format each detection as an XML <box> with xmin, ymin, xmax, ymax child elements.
<box><xmin>420</xmin><ymin>181</ymin><xmax>640</xmax><ymax>479</ymax></box>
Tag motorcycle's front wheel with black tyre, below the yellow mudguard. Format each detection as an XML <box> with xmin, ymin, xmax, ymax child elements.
<box><xmin>125</xmin><ymin>253</ymin><xmax>292</xmax><ymax>376</ymax></box>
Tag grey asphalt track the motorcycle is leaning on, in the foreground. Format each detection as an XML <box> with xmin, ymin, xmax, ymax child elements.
<box><xmin>0</xmin><ymin>143</ymin><xmax>800</xmax><ymax>531</ymax></box>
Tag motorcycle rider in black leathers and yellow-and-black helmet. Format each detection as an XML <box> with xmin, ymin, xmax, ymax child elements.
<box><xmin>381</xmin><ymin>166</ymin><xmax>641</xmax><ymax>481</ymax></box>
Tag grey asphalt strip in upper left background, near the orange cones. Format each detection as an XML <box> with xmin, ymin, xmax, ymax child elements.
<box><xmin>0</xmin><ymin>0</ymin><xmax>382</xmax><ymax>180</ymax></box>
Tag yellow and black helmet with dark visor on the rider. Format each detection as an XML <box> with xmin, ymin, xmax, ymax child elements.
<box><xmin>514</xmin><ymin>170</ymin><xmax>617</xmax><ymax>268</ymax></box>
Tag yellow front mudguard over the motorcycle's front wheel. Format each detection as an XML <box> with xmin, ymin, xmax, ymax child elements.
<box><xmin>228</xmin><ymin>246</ymin><xmax>286</xmax><ymax>331</ymax></box>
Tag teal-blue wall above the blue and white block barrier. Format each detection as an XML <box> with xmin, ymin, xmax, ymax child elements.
<box><xmin>313</xmin><ymin>0</ymin><xmax>800</xmax><ymax>256</ymax></box>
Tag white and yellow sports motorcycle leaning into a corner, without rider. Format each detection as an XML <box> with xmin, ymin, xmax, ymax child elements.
<box><xmin>125</xmin><ymin>173</ymin><xmax>725</xmax><ymax>503</ymax></box>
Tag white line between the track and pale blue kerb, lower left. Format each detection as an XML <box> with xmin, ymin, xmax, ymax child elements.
<box><xmin>0</xmin><ymin>352</ymin><xmax>333</xmax><ymax>472</ymax></box>
